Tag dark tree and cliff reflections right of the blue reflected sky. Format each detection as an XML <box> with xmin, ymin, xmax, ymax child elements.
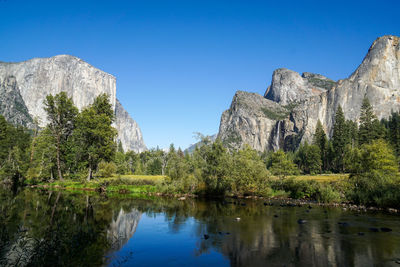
<box><xmin>126</xmin><ymin>199</ymin><xmax>400</xmax><ymax>266</ymax></box>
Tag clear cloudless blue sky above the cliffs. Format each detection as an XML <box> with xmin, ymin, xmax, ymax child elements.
<box><xmin>0</xmin><ymin>0</ymin><xmax>400</xmax><ymax>148</ymax></box>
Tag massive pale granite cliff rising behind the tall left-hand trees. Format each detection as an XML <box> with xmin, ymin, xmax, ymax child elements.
<box><xmin>0</xmin><ymin>55</ymin><xmax>146</xmax><ymax>152</ymax></box>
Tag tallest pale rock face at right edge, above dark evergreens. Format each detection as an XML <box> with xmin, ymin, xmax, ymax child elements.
<box><xmin>327</xmin><ymin>36</ymin><xmax>400</xmax><ymax>133</ymax></box>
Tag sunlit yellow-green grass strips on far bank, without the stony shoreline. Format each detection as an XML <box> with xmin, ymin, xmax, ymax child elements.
<box><xmin>25</xmin><ymin>174</ymin><xmax>349</xmax><ymax>202</ymax></box>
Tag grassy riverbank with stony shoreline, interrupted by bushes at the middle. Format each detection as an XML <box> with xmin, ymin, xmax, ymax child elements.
<box><xmin>22</xmin><ymin>174</ymin><xmax>400</xmax><ymax>216</ymax></box>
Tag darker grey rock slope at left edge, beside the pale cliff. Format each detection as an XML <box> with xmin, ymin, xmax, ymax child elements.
<box><xmin>0</xmin><ymin>76</ymin><xmax>33</xmax><ymax>127</ymax></box>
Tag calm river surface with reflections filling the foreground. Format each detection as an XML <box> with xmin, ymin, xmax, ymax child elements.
<box><xmin>0</xmin><ymin>189</ymin><xmax>400</xmax><ymax>266</ymax></box>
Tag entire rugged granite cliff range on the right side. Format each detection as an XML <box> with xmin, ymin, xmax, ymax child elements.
<box><xmin>218</xmin><ymin>35</ymin><xmax>400</xmax><ymax>151</ymax></box>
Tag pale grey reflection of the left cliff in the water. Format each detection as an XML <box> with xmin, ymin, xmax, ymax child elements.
<box><xmin>107</xmin><ymin>208</ymin><xmax>142</xmax><ymax>251</ymax></box>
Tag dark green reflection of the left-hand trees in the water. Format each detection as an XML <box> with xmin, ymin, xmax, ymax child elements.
<box><xmin>0</xmin><ymin>190</ymin><xmax>142</xmax><ymax>266</ymax></box>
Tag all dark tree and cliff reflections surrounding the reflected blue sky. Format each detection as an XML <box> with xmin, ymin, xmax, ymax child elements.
<box><xmin>0</xmin><ymin>190</ymin><xmax>400</xmax><ymax>266</ymax></box>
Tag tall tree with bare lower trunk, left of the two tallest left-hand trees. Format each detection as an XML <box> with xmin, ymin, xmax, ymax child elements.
<box><xmin>44</xmin><ymin>92</ymin><xmax>78</xmax><ymax>180</ymax></box>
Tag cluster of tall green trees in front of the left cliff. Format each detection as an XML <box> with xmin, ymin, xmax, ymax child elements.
<box><xmin>0</xmin><ymin>92</ymin><xmax>117</xmax><ymax>182</ymax></box>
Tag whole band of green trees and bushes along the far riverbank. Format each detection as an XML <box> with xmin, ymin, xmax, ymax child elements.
<box><xmin>0</xmin><ymin>92</ymin><xmax>400</xmax><ymax>207</ymax></box>
